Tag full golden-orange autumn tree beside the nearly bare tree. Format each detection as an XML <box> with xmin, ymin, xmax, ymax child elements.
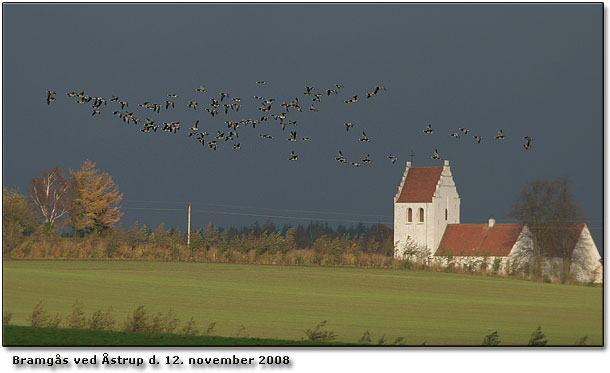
<box><xmin>70</xmin><ymin>160</ymin><xmax>123</xmax><ymax>233</ymax></box>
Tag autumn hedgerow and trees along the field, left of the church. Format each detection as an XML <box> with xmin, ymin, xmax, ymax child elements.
<box><xmin>3</xmin><ymin>221</ymin><xmax>396</xmax><ymax>268</ymax></box>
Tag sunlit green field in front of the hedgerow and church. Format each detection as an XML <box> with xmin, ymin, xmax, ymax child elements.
<box><xmin>3</xmin><ymin>261</ymin><xmax>603</xmax><ymax>345</ymax></box>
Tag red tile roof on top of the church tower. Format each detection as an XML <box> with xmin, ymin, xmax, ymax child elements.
<box><xmin>397</xmin><ymin>167</ymin><xmax>443</xmax><ymax>202</ymax></box>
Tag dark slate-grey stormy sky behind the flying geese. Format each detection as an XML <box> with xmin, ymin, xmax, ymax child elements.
<box><xmin>2</xmin><ymin>4</ymin><xmax>603</xmax><ymax>248</ymax></box>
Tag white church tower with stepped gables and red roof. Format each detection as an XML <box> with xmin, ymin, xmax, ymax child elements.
<box><xmin>394</xmin><ymin>160</ymin><xmax>460</xmax><ymax>256</ymax></box>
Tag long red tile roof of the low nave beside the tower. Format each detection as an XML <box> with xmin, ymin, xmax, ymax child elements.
<box><xmin>435</xmin><ymin>224</ymin><xmax>523</xmax><ymax>256</ymax></box>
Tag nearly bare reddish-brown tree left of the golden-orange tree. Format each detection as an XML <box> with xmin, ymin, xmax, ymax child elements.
<box><xmin>28</xmin><ymin>167</ymin><xmax>70</xmax><ymax>227</ymax></box>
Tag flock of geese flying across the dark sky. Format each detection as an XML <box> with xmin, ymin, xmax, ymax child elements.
<box><xmin>46</xmin><ymin>80</ymin><xmax>532</xmax><ymax>167</ymax></box>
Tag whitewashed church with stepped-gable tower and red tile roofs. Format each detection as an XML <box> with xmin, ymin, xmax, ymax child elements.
<box><xmin>394</xmin><ymin>160</ymin><xmax>603</xmax><ymax>282</ymax></box>
